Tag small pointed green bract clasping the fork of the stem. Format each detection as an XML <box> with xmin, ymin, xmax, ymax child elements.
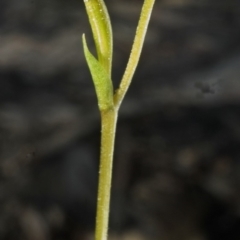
<box><xmin>82</xmin><ymin>34</ymin><xmax>113</xmax><ymax>110</ymax></box>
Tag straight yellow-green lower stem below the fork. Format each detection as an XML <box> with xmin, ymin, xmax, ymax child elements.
<box><xmin>95</xmin><ymin>108</ymin><xmax>118</xmax><ymax>240</ymax></box>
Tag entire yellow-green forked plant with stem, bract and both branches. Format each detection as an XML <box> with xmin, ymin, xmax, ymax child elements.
<box><xmin>82</xmin><ymin>0</ymin><xmax>155</xmax><ymax>240</ymax></box>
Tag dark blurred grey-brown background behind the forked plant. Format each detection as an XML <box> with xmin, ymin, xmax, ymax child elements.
<box><xmin>0</xmin><ymin>0</ymin><xmax>240</xmax><ymax>240</ymax></box>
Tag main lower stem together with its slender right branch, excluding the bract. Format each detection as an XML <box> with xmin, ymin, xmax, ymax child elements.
<box><xmin>93</xmin><ymin>0</ymin><xmax>155</xmax><ymax>240</ymax></box>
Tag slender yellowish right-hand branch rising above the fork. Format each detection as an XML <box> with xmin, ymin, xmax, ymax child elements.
<box><xmin>114</xmin><ymin>0</ymin><xmax>155</xmax><ymax>106</ymax></box>
